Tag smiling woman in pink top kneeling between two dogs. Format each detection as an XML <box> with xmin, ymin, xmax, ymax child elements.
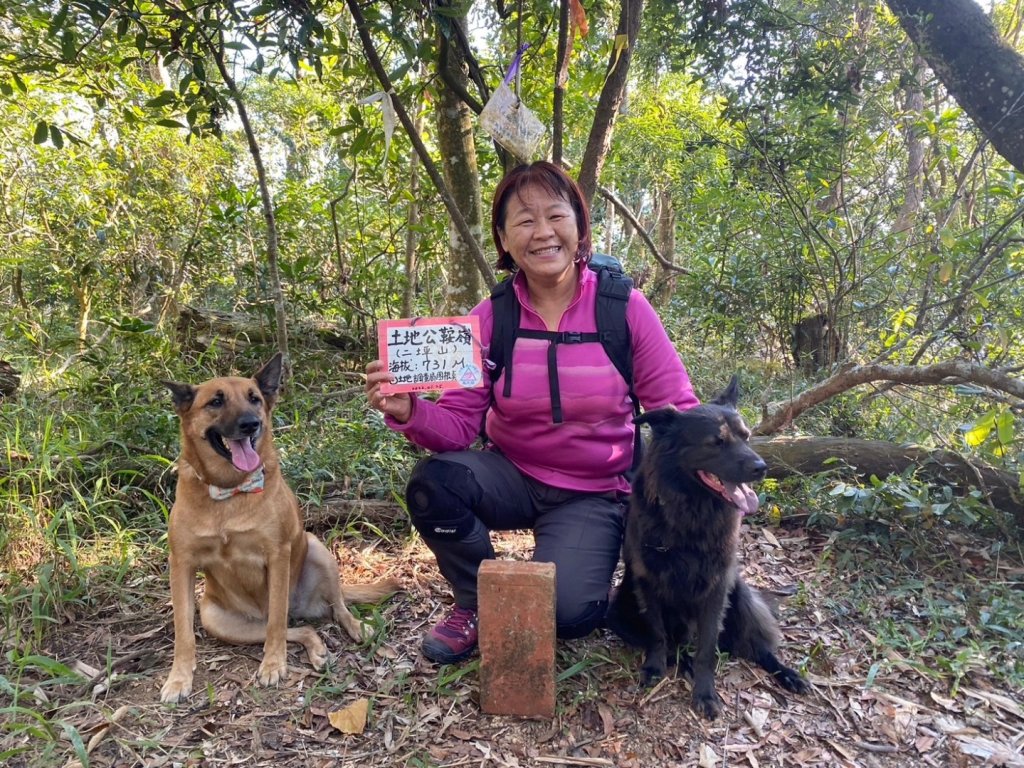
<box><xmin>367</xmin><ymin>162</ymin><xmax>697</xmax><ymax>664</ymax></box>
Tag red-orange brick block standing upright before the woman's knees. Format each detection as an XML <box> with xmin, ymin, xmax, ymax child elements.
<box><xmin>477</xmin><ymin>560</ymin><xmax>555</xmax><ymax>718</ymax></box>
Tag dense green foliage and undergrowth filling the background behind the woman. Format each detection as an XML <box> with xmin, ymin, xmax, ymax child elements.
<box><xmin>0</xmin><ymin>0</ymin><xmax>1024</xmax><ymax>761</ymax></box>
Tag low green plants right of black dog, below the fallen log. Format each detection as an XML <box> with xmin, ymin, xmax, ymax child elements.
<box><xmin>773</xmin><ymin>466</ymin><xmax>1024</xmax><ymax>695</ymax></box>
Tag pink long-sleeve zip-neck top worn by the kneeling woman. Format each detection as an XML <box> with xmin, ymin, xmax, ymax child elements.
<box><xmin>386</xmin><ymin>268</ymin><xmax>699</xmax><ymax>493</ymax></box>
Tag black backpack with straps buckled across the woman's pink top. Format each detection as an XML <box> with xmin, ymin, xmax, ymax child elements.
<box><xmin>487</xmin><ymin>253</ymin><xmax>641</xmax><ymax>469</ymax></box>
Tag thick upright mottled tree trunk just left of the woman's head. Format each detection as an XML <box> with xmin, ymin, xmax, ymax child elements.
<box><xmin>437</xmin><ymin>11</ymin><xmax>483</xmax><ymax>314</ymax></box>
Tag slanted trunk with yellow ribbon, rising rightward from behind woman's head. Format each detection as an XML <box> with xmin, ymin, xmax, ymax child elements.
<box><xmin>577</xmin><ymin>0</ymin><xmax>644</xmax><ymax>205</ymax></box>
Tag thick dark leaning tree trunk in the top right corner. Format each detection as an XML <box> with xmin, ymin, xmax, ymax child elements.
<box><xmin>887</xmin><ymin>0</ymin><xmax>1024</xmax><ymax>171</ymax></box>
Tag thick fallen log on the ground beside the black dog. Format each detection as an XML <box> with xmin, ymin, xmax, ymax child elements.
<box><xmin>751</xmin><ymin>437</ymin><xmax>1024</xmax><ymax>529</ymax></box>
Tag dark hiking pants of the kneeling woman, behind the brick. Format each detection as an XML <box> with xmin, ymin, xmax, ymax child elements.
<box><xmin>406</xmin><ymin>451</ymin><xmax>626</xmax><ymax>638</ymax></box>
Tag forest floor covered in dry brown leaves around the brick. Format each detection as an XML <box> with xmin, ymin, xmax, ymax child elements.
<box><xmin>0</xmin><ymin>512</ymin><xmax>1024</xmax><ymax>768</ymax></box>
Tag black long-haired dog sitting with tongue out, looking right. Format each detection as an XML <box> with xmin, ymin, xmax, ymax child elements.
<box><xmin>608</xmin><ymin>377</ymin><xmax>808</xmax><ymax>718</ymax></box>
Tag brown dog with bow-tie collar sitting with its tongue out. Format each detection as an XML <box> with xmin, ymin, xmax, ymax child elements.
<box><xmin>160</xmin><ymin>353</ymin><xmax>398</xmax><ymax>702</ymax></box>
